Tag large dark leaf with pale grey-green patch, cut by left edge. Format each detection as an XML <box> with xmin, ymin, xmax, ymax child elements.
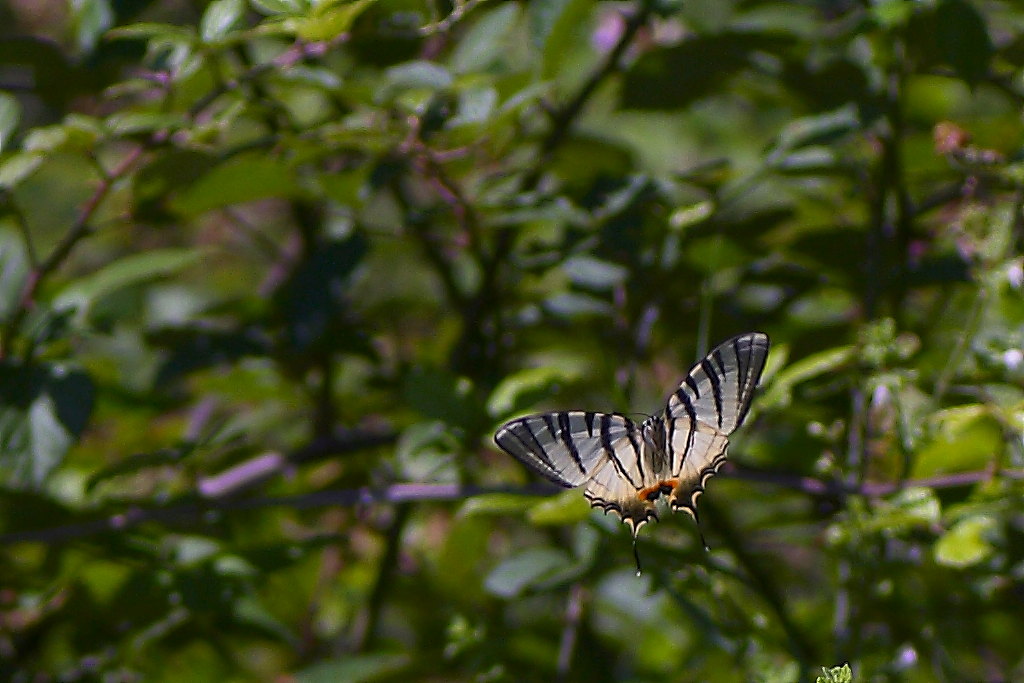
<box><xmin>0</xmin><ymin>361</ymin><xmax>94</xmax><ymax>488</ymax></box>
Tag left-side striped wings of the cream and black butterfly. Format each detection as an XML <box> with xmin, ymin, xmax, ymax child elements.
<box><xmin>495</xmin><ymin>411</ymin><xmax>658</xmax><ymax>536</ymax></box>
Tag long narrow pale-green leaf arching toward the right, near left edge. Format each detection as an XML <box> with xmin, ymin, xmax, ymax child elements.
<box><xmin>53</xmin><ymin>248</ymin><xmax>207</xmax><ymax>318</ymax></box>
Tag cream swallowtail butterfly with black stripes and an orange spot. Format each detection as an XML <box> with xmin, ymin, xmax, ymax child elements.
<box><xmin>495</xmin><ymin>332</ymin><xmax>768</xmax><ymax>536</ymax></box>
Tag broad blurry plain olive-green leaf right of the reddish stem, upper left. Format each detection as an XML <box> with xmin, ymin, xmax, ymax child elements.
<box><xmin>171</xmin><ymin>155</ymin><xmax>299</xmax><ymax>217</ymax></box>
